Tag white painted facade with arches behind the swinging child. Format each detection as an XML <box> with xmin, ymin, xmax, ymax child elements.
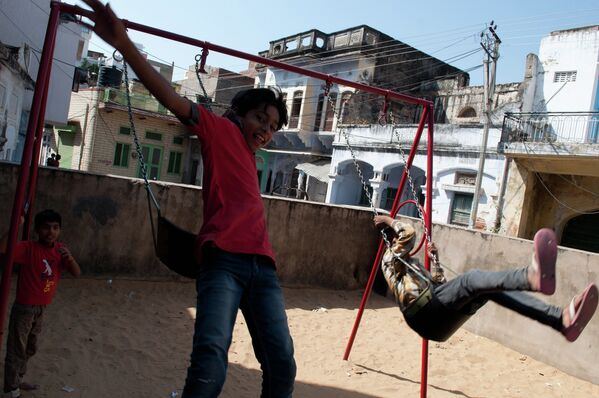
<box><xmin>326</xmin><ymin>125</ymin><xmax>505</xmax><ymax>228</ymax></box>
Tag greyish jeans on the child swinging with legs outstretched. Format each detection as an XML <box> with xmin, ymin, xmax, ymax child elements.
<box><xmin>435</xmin><ymin>268</ymin><xmax>562</xmax><ymax>331</ymax></box>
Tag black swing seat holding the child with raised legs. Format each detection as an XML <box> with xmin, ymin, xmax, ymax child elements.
<box><xmin>403</xmin><ymin>284</ymin><xmax>472</xmax><ymax>342</ymax></box>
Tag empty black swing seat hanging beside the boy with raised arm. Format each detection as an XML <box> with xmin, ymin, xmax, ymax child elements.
<box><xmin>156</xmin><ymin>216</ymin><xmax>199</xmax><ymax>279</ymax></box>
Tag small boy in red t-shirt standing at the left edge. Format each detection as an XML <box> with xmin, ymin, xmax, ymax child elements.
<box><xmin>0</xmin><ymin>210</ymin><xmax>81</xmax><ymax>398</ymax></box>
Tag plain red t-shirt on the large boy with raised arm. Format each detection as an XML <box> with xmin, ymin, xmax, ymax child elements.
<box><xmin>189</xmin><ymin>105</ymin><xmax>275</xmax><ymax>264</ymax></box>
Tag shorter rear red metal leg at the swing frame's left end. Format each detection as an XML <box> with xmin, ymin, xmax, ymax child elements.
<box><xmin>21</xmin><ymin>23</ymin><xmax>56</xmax><ymax>240</ymax></box>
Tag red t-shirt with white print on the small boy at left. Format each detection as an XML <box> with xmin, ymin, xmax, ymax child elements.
<box><xmin>14</xmin><ymin>241</ymin><xmax>63</xmax><ymax>305</ymax></box>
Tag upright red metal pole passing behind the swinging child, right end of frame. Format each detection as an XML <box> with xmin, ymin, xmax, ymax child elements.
<box><xmin>420</xmin><ymin>106</ymin><xmax>434</xmax><ymax>398</ymax></box>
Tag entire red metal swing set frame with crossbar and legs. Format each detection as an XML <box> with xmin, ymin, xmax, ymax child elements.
<box><xmin>0</xmin><ymin>1</ymin><xmax>434</xmax><ymax>398</ymax></box>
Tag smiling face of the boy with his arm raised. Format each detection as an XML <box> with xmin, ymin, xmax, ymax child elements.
<box><xmin>240</xmin><ymin>105</ymin><xmax>279</xmax><ymax>152</ymax></box>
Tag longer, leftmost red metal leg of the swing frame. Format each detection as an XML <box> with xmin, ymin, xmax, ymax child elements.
<box><xmin>0</xmin><ymin>2</ymin><xmax>60</xmax><ymax>339</ymax></box>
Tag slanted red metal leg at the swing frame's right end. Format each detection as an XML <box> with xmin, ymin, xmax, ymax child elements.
<box><xmin>343</xmin><ymin>107</ymin><xmax>428</xmax><ymax>361</ymax></box>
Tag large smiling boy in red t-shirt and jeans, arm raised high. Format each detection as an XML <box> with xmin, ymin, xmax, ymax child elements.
<box><xmin>84</xmin><ymin>0</ymin><xmax>296</xmax><ymax>398</ymax></box>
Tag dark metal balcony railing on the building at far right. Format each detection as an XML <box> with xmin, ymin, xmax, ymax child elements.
<box><xmin>501</xmin><ymin>112</ymin><xmax>599</xmax><ymax>144</ymax></box>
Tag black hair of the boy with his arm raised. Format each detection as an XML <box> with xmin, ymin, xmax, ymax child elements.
<box><xmin>224</xmin><ymin>88</ymin><xmax>288</xmax><ymax>130</ymax></box>
